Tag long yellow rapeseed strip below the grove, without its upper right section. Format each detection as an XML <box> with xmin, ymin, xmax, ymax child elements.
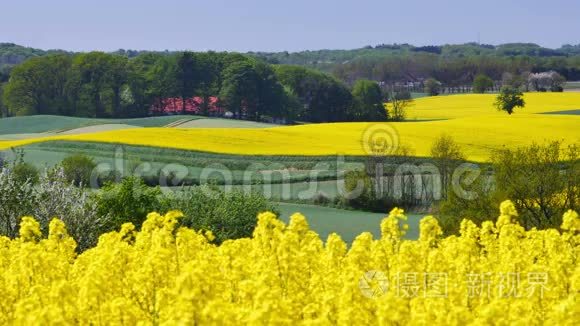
<box><xmin>0</xmin><ymin>114</ymin><xmax>580</xmax><ymax>162</ymax></box>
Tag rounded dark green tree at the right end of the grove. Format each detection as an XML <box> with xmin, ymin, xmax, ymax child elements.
<box><xmin>349</xmin><ymin>79</ymin><xmax>387</xmax><ymax>121</ymax></box>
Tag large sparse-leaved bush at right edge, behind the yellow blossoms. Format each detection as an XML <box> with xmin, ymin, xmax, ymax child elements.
<box><xmin>492</xmin><ymin>141</ymin><xmax>580</xmax><ymax>228</ymax></box>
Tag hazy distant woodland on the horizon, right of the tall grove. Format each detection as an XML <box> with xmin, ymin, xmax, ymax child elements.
<box><xmin>253</xmin><ymin>43</ymin><xmax>580</xmax><ymax>87</ymax></box>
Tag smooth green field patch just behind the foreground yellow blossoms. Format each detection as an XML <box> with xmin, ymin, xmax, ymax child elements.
<box><xmin>278</xmin><ymin>203</ymin><xmax>423</xmax><ymax>243</ymax></box>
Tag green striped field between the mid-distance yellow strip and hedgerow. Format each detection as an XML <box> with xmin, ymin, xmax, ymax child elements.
<box><xmin>13</xmin><ymin>141</ymin><xmax>374</xmax><ymax>188</ymax></box>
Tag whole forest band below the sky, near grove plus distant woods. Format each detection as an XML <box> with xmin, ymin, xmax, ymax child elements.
<box><xmin>0</xmin><ymin>43</ymin><xmax>580</xmax><ymax>122</ymax></box>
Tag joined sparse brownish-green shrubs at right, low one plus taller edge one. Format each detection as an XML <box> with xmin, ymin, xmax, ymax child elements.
<box><xmin>439</xmin><ymin>142</ymin><xmax>580</xmax><ymax>233</ymax></box>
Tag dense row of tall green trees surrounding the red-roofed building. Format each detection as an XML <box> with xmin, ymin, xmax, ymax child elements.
<box><xmin>0</xmin><ymin>52</ymin><xmax>387</xmax><ymax>122</ymax></box>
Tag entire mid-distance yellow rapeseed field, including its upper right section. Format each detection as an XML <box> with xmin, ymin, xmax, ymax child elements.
<box><xmin>0</xmin><ymin>93</ymin><xmax>580</xmax><ymax>161</ymax></box>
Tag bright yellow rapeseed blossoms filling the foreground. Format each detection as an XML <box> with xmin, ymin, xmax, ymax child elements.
<box><xmin>0</xmin><ymin>201</ymin><xmax>580</xmax><ymax>325</ymax></box>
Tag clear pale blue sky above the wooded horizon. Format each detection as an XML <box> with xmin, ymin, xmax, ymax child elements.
<box><xmin>0</xmin><ymin>0</ymin><xmax>580</xmax><ymax>52</ymax></box>
